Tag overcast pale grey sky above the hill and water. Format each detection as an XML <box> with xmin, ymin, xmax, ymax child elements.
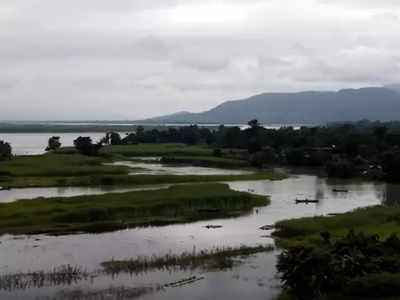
<box><xmin>0</xmin><ymin>0</ymin><xmax>400</xmax><ymax>120</ymax></box>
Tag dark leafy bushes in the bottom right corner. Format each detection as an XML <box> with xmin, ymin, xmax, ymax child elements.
<box><xmin>277</xmin><ymin>231</ymin><xmax>400</xmax><ymax>299</ymax></box>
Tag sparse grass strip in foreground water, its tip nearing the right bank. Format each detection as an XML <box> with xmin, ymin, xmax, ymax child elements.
<box><xmin>101</xmin><ymin>245</ymin><xmax>274</xmax><ymax>274</ymax></box>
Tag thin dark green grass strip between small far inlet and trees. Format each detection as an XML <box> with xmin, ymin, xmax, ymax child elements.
<box><xmin>161</xmin><ymin>156</ymin><xmax>250</xmax><ymax>169</ymax></box>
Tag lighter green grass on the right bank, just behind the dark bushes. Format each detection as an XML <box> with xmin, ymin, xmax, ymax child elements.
<box><xmin>274</xmin><ymin>206</ymin><xmax>400</xmax><ymax>245</ymax></box>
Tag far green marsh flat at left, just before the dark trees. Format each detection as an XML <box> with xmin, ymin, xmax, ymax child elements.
<box><xmin>0</xmin><ymin>144</ymin><xmax>286</xmax><ymax>188</ymax></box>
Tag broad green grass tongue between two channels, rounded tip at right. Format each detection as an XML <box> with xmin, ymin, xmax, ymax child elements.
<box><xmin>0</xmin><ymin>183</ymin><xmax>269</xmax><ymax>234</ymax></box>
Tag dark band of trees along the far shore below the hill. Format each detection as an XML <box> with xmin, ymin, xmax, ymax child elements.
<box><xmin>0</xmin><ymin>120</ymin><xmax>400</xmax><ymax>180</ymax></box>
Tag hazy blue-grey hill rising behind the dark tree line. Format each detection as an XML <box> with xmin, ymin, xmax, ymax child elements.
<box><xmin>137</xmin><ymin>86</ymin><xmax>400</xmax><ymax>124</ymax></box>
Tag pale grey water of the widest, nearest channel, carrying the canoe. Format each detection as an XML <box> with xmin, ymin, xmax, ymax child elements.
<box><xmin>0</xmin><ymin>164</ymin><xmax>400</xmax><ymax>300</ymax></box>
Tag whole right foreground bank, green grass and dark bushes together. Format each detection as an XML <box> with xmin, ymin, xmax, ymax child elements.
<box><xmin>274</xmin><ymin>206</ymin><xmax>400</xmax><ymax>300</ymax></box>
